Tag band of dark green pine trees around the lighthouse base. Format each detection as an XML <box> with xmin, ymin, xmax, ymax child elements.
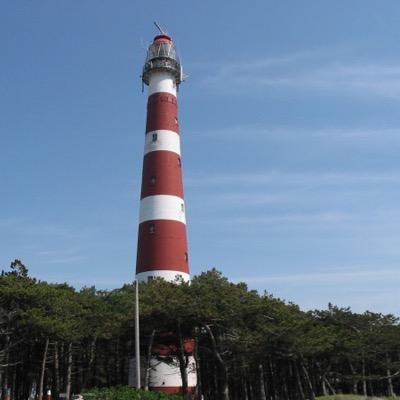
<box><xmin>0</xmin><ymin>260</ymin><xmax>400</xmax><ymax>400</ymax></box>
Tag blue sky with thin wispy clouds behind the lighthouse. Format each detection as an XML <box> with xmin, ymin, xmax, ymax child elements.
<box><xmin>0</xmin><ymin>0</ymin><xmax>400</xmax><ymax>315</ymax></box>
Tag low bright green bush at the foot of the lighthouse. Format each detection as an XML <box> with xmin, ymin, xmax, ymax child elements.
<box><xmin>82</xmin><ymin>386</ymin><xmax>182</xmax><ymax>400</ymax></box>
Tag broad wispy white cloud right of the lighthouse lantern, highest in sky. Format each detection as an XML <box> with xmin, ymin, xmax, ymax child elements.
<box><xmin>201</xmin><ymin>46</ymin><xmax>400</xmax><ymax>100</ymax></box>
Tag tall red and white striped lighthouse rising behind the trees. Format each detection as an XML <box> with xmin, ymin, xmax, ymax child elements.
<box><xmin>136</xmin><ymin>33</ymin><xmax>197</xmax><ymax>393</ymax></box>
